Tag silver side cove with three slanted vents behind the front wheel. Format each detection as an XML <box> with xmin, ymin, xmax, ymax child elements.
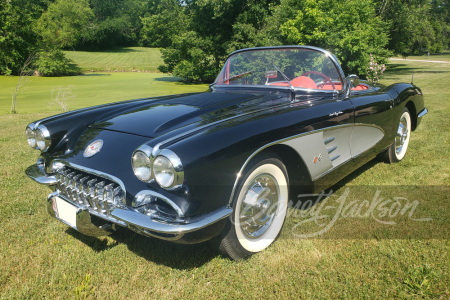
<box><xmin>281</xmin><ymin>124</ymin><xmax>384</xmax><ymax>180</ymax></box>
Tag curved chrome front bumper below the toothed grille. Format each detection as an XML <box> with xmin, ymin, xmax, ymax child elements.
<box><xmin>25</xmin><ymin>165</ymin><xmax>232</xmax><ymax>241</ymax></box>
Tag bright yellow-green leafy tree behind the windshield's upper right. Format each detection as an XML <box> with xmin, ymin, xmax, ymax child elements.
<box><xmin>281</xmin><ymin>0</ymin><xmax>390</xmax><ymax>74</ymax></box>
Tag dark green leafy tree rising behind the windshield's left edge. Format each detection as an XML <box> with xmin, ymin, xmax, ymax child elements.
<box><xmin>159</xmin><ymin>0</ymin><xmax>277</xmax><ymax>82</ymax></box>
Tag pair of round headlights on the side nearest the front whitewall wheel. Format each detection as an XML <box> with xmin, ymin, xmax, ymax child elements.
<box><xmin>131</xmin><ymin>145</ymin><xmax>184</xmax><ymax>190</ymax></box>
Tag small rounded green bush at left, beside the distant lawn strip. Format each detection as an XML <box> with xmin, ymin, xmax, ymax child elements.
<box><xmin>35</xmin><ymin>49</ymin><xmax>81</xmax><ymax>77</ymax></box>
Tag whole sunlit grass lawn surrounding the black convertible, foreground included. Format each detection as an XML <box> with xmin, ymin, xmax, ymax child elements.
<box><xmin>0</xmin><ymin>56</ymin><xmax>450</xmax><ymax>299</ymax></box>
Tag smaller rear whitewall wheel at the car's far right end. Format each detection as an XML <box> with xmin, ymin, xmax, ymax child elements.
<box><xmin>386</xmin><ymin>107</ymin><xmax>411</xmax><ymax>163</ymax></box>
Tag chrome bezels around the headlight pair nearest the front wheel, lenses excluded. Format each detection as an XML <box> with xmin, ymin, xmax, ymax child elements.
<box><xmin>131</xmin><ymin>145</ymin><xmax>184</xmax><ymax>190</ymax></box>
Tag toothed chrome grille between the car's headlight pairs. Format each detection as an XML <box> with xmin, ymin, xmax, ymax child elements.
<box><xmin>56</xmin><ymin>166</ymin><xmax>125</xmax><ymax>218</ymax></box>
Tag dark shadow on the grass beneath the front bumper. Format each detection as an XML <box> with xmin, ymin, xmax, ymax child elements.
<box><xmin>66</xmin><ymin>227</ymin><xmax>218</xmax><ymax>270</ymax></box>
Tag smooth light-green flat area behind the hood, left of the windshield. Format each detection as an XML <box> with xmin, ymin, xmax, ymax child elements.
<box><xmin>0</xmin><ymin>72</ymin><xmax>208</xmax><ymax>114</ymax></box>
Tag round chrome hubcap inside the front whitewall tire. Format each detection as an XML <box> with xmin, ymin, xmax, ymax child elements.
<box><xmin>239</xmin><ymin>174</ymin><xmax>280</xmax><ymax>239</ymax></box>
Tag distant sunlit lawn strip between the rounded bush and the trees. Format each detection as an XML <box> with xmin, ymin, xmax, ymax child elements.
<box><xmin>64</xmin><ymin>47</ymin><xmax>163</xmax><ymax>72</ymax></box>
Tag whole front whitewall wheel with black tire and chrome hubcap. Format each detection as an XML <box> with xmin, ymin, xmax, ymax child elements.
<box><xmin>219</xmin><ymin>158</ymin><xmax>289</xmax><ymax>260</ymax></box>
